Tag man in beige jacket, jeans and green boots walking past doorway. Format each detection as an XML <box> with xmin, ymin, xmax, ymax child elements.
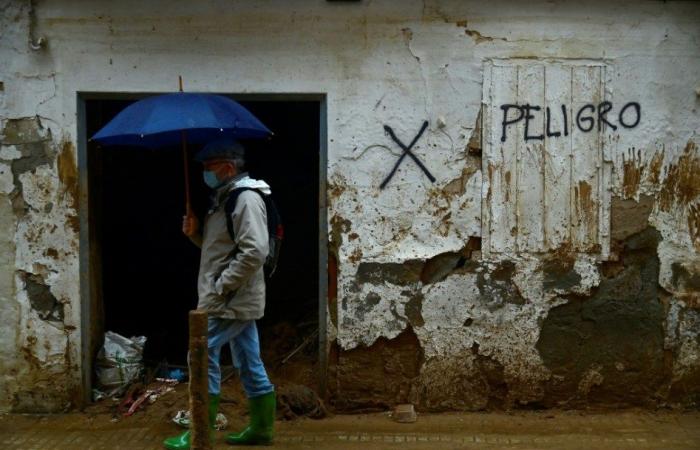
<box><xmin>164</xmin><ymin>139</ymin><xmax>275</xmax><ymax>450</ymax></box>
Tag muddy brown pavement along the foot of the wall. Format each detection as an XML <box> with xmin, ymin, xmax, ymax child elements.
<box><xmin>0</xmin><ymin>411</ymin><xmax>700</xmax><ymax>450</ymax></box>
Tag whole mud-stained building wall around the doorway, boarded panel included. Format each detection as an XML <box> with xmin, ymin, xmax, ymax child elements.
<box><xmin>0</xmin><ymin>0</ymin><xmax>700</xmax><ymax>411</ymax></box>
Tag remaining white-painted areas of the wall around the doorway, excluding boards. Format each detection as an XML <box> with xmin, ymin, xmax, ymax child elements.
<box><xmin>0</xmin><ymin>0</ymin><xmax>700</xmax><ymax>410</ymax></box>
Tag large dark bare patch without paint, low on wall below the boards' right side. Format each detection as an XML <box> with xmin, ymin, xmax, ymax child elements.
<box><xmin>537</xmin><ymin>228</ymin><xmax>667</xmax><ymax>406</ymax></box>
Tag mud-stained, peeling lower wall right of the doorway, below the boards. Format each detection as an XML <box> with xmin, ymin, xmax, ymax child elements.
<box><xmin>331</xmin><ymin>152</ymin><xmax>700</xmax><ymax>411</ymax></box>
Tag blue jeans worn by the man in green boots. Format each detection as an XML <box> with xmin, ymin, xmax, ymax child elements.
<box><xmin>207</xmin><ymin>318</ymin><xmax>275</xmax><ymax>398</ymax></box>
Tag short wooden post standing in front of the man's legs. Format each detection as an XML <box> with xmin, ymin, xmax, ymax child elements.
<box><xmin>189</xmin><ymin>310</ymin><xmax>211</xmax><ymax>450</ymax></box>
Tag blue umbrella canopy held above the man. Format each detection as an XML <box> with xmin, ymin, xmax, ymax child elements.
<box><xmin>92</xmin><ymin>92</ymin><xmax>272</xmax><ymax>148</ymax></box>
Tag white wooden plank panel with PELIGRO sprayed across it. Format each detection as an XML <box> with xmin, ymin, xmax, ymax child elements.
<box><xmin>482</xmin><ymin>60</ymin><xmax>612</xmax><ymax>258</ymax></box>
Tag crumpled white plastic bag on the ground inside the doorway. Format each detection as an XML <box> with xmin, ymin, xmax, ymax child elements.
<box><xmin>96</xmin><ymin>331</ymin><xmax>146</xmax><ymax>396</ymax></box>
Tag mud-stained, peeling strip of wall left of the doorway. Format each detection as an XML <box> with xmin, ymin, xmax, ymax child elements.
<box><xmin>0</xmin><ymin>116</ymin><xmax>80</xmax><ymax>411</ymax></box>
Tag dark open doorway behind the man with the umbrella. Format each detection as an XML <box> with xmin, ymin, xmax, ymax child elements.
<box><xmin>84</xmin><ymin>97</ymin><xmax>325</xmax><ymax>390</ymax></box>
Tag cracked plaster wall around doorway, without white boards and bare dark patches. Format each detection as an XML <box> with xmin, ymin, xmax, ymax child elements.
<box><xmin>0</xmin><ymin>0</ymin><xmax>700</xmax><ymax>410</ymax></box>
